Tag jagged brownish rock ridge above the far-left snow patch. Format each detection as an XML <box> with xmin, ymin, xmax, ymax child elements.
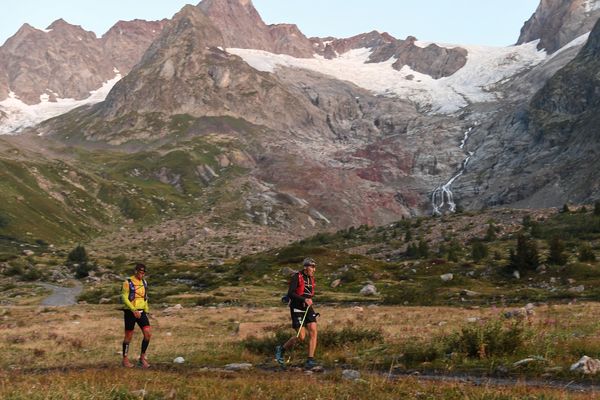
<box><xmin>0</xmin><ymin>19</ymin><xmax>163</xmax><ymax>104</ymax></box>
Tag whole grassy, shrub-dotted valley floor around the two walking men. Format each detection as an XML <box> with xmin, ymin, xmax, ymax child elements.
<box><xmin>0</xmin><ymin>205</ymin><xmax>600</xmax><ymax>399</ymax></box>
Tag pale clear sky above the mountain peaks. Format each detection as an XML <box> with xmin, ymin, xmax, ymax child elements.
<box><xmin>0</xmin><ymin>0</ymin><xmax>540</xmax><ymax>46</ymax></box>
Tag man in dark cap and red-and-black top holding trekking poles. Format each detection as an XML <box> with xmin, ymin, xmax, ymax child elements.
<box><xmin>275</xmin><ymin>258</ymin><xmax>319</xmax><ymax>369</ymax></box>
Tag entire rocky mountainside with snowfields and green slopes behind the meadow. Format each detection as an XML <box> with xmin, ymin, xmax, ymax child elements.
<box><xmin>0</xmin><ymin>0</ymin><xmax>600</xmax><ymax>259</ymax></box>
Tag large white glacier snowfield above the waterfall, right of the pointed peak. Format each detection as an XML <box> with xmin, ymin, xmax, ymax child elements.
<box><xmin>227</xmin><ymin>41</ymin><xmax>547</xmax><ymax>114</ymax></box>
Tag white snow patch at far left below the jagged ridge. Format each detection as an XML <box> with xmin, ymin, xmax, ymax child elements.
<box><xmin>0</xmin><ymin>72</ymin><xmax>122</xmax><ymax>135</ymax></box>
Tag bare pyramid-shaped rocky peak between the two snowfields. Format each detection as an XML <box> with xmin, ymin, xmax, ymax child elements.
<box><xmin>41</xmin><ymin>6</ymin><xmax>327</xmax><ymax>142</ymax></box>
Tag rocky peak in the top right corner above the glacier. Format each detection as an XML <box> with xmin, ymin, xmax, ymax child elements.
<box><xmin>517</xmin><ymin>0</ymin><xmax>600</xmax><ymax>53</ymax></box>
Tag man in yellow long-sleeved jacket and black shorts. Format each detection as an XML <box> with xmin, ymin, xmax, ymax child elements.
<box><xmin>121</xmin><ymin>264</ymin><xmax>152</xmax><ymax>368</ymax></box>
